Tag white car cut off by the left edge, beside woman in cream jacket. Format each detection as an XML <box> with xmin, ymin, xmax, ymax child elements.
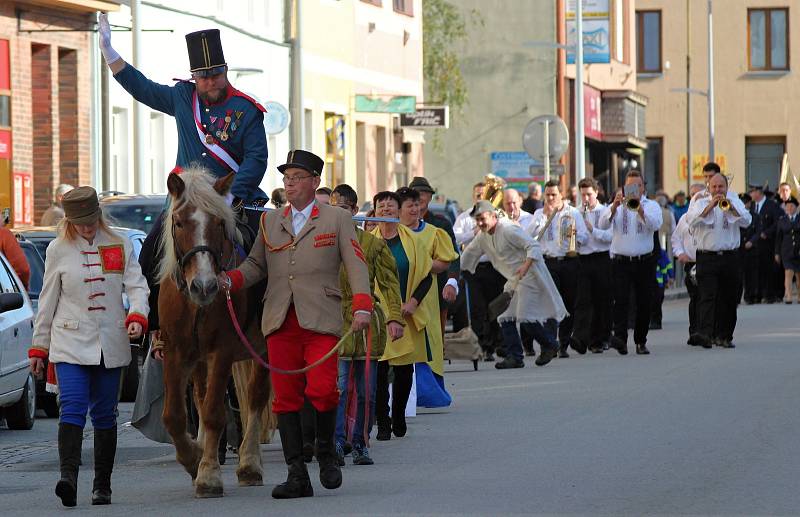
<box><xmin>0</xmin><ymin>254</ymin><xmax>36</xmax><ymax>429</ymax></box>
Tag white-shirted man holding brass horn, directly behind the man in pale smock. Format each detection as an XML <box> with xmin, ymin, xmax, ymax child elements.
<box><xmin>529</xmin><ymin>180</ymin><xmax>588</xmax><ymax>358</ymax></box>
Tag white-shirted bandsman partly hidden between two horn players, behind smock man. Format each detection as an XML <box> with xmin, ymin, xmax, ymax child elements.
<box><xmin>572</xmin><ymin>178</ymin><xmax>612</xmax><ymax>354</ymax></box>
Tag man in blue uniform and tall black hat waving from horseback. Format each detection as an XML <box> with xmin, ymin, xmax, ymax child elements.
<box><xmin>99</xmin><ymin>14</ymin><xmax>268</xmax><ymax>340</ymax></box>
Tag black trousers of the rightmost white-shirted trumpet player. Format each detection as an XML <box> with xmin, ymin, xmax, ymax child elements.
<box><xmin>697</xmin><ymin>251</ymin><xmax>740</xmax><ymax>341</ymax></box>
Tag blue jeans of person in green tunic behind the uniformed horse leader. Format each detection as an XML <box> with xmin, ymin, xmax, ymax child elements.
<box><xmin>336</xmin><ymin>359</ymin><xmax>378</xmax><ymax>447</ymax></box>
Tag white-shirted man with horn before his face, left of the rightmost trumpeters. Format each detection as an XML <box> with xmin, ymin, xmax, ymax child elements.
<box><xmin>599</xmin><ymin>170</ymin><xmax>663</xmax><ymax>355</ymax></box>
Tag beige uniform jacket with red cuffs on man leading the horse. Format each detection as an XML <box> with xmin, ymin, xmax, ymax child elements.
<box><xmin>228</xmin><ymin>201</ymin><xmax>372</xmax><ymax>336</ymax></box>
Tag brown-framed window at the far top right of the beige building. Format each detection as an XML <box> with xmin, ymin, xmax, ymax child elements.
<box><xmin>747</xmin><ymin>8</ymin><xmax>789</xmax><ymax>70</ymax></box>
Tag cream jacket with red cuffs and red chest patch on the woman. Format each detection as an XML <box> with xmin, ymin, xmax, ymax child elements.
<box><xmin>32</xmin><ymin>229</ymin><xmax>150</xmax><ymax>368</ymax></box>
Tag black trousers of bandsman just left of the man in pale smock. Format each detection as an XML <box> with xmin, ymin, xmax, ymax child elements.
<box><xmin>465</xmin><ymin>262</ymin><xmax>506</xmax><ymax>352</ymax></box>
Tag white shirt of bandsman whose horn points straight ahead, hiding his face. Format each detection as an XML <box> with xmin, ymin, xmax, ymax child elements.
<box><xmin>600</xmin><ymin>197</ymin><xmax>663</xmax><ymax>257</ymax></box>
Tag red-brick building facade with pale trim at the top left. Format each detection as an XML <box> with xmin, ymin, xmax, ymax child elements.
<box><xmin>0</xmin><ymin>0</ymin><xmax>119</xmax><ymax>225</ymax></box>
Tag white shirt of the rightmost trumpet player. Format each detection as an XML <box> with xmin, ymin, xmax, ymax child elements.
<box><xmin>681</xmin><ymin>196</ymin><xmax>752</xmax><ymax>251</ymax></box>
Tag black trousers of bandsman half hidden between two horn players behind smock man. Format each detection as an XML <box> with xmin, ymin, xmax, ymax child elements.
<box><xmin>573</xmin><ymin>251</ymin><xmax>611</xmax><ymax>346</ymax></box>
